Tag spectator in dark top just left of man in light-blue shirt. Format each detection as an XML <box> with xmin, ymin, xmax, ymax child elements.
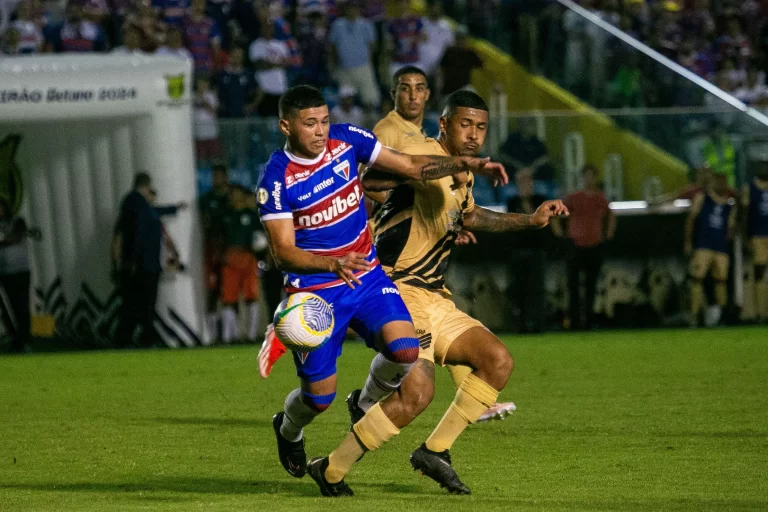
<box><xmin>297</xmin><ymin>11</ymin><xmax>331</xmax><ymax>88</ymax></box>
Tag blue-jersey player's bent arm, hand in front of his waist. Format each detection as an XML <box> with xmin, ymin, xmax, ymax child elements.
<box><xmin>263</xmin><ymin>219</ymin><xmax>371</xmax><ymax>288</ymax></box>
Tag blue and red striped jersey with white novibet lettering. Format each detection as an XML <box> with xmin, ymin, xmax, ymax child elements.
<box><xmin>257</xmin><ymin>124</ymin><xmax>381</xmax><ymax>293</ymax></box>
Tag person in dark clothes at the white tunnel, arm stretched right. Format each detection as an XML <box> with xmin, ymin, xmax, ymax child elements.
<box><xmin>112</xmin><ymin>172</ymin><xmax>186</xmax><ymax>347</ymax></box>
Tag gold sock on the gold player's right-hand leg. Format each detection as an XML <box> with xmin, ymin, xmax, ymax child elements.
<box><xmin>425</xmin><ymin>373</ymin><xmax>499</xmax><ymax>452</ymax></box>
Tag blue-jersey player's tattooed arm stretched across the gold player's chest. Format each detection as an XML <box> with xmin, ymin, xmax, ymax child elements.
<box><xmin>373</xmin><ymin>147</ymin><xmax>509</xmax><ymax>186</ymax></box>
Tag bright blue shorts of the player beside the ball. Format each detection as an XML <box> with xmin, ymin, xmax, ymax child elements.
<box><xmin>293</xmin><ymin>266</ymin><xmax>412</xmax><ymax>382</ymax></box>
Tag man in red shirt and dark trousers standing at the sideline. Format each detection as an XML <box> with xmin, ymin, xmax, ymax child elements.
<box><xmin>554</xmin><ymin>165</ymin><xmax>616</xmax><ymax>329</ymax></box>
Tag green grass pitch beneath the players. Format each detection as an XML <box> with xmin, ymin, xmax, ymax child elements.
<box><xmin>0</xmin><ymin>328</ymin><xmax>768</xmax><ymax>512</ymax></box>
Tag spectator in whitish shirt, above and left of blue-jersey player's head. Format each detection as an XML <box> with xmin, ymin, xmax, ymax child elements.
<box><xmin>248</xmin><ymin>19</ymin><xmax>290</xmax><ymax>117</ymax></box>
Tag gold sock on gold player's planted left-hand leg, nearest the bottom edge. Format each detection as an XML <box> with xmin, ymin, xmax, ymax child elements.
<box><xmin>325</xmin><ymin>404</ymin><xmax>400</xmax><ymax>484</ymax></box>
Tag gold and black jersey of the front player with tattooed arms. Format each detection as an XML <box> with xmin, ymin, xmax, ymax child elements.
<box><xmin>372</xmin><ymin>139</ymin><xmax>475</xmax><ymax>296</ymax></box>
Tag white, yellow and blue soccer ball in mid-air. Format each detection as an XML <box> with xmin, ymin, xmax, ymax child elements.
<box><xmin>273</xmin><ymin>292</ymin><xmax>333</xmax><ymax>353</ymax></box>
